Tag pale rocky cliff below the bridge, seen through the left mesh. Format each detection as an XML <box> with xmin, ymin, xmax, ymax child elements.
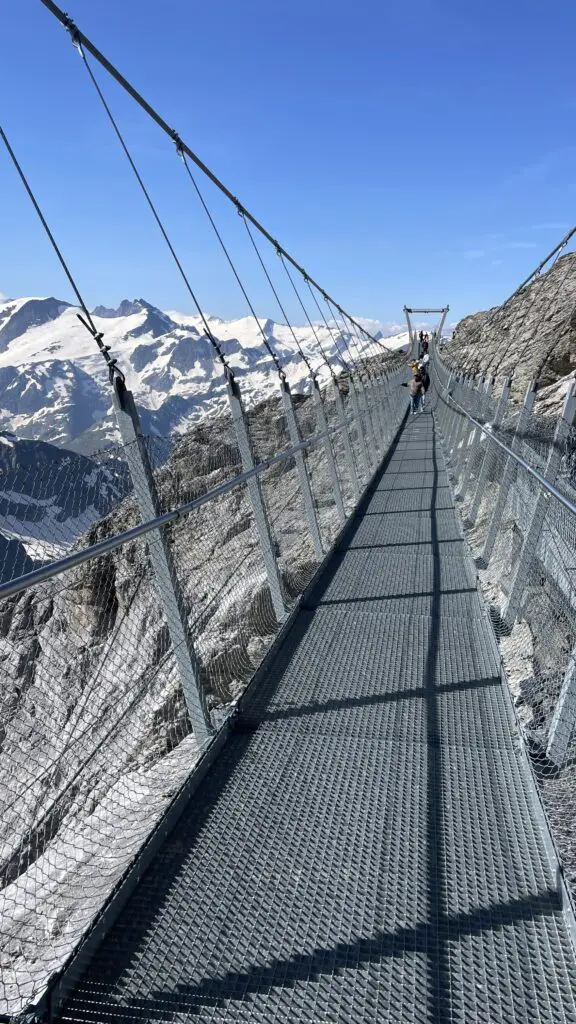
<box><xmin>0</xmin><ymin>385</ymin><xmax>349</xmax><ymax>1012</ymax></box>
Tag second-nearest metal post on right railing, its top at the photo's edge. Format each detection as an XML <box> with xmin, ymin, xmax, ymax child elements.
<box><xmin>502</xmin><ymin>383</ymin><xmax>576</xmax><ymax>627</ymax></box>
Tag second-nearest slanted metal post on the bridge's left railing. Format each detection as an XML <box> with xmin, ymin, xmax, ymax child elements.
<box><xmin>228</xmin><ymin>376</ymin><xmax>287</xmax><ymax>623</ymax></box>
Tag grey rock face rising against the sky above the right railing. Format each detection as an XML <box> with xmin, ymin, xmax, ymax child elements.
<box><xmin>445</xmin><ymin>253</ymin><xmax>576</xmax><ymax>411</ymax></box>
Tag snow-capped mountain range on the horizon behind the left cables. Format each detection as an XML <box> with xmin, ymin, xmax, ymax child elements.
<box><xmin>0</xmin><ymin>298</ymin><xmax>407</xmax><ymax>453</ymax></box>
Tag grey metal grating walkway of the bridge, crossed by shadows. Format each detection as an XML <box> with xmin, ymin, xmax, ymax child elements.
<box><xmin>56</xmin><ymin>414</ymin><xmax>576</xmax><ymax>1024</ymax></box>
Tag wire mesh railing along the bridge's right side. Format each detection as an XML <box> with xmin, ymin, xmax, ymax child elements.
<box><xmin>435</xmin><ymin>353</ymin><xmax>576</xmax><ymax>898</ymax></box>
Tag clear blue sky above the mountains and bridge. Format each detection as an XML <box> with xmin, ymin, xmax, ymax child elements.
<box><xmin>0</xmin><ymin>0</ymin><xmax>576</xmax><ymax>322</ymax></box>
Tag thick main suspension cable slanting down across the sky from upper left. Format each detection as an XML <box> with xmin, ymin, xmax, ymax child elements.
<box><xmin>40</xmin><ymin>0</ymin><xmax>375</xmax><ymax>352</ymax></box>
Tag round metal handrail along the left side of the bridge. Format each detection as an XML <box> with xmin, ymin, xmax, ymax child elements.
<box><xmin>0</xmin><ymin>413</ymin><xmax>343</xmax><ymax>600</ymax></box>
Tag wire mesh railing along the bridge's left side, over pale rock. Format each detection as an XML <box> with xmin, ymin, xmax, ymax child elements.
<box><xmin>0</xmin><ymin>360</ymin><xmax>407</xmax><ymax>1015</ymax></box>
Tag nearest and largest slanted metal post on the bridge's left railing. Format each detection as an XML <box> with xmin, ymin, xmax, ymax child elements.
<box><xmin>113</xmin><ymin>377</ymin><xmax>214</xmax><ymax>745</ymax></box>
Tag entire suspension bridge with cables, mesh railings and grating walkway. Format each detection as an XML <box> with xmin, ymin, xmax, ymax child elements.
<box><xmin>0</xmin><ymin>0</ymin><xmax>576</xmax><ymax>1024</ymax></box>
